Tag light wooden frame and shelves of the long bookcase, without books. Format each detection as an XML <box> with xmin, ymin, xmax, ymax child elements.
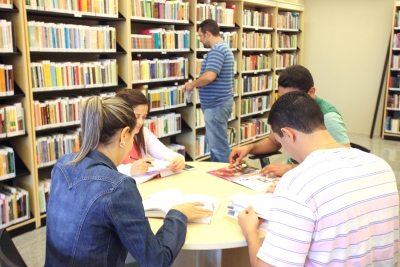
<box><xmin>0</xmin><ymin>0</ymin><xmax>304</xmax><ymax>233</ymax></box>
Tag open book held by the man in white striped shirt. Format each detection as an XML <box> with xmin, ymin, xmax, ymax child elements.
<box><xmin>226</xmin><ymin>193</ymin><xmax>273</xmax><ymax>231</ymax></box>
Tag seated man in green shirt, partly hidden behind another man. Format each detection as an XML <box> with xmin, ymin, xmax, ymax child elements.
<box><xmin>229</xmin><ymin>65</ymin><xmax>350</xmax><ymax>177</ymax></box>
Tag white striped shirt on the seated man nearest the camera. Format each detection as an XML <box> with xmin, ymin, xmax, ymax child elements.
<box><xmin>257</xmin><ymin>148</ymin><xmax>399</xmax><ymax>267</ymax></box>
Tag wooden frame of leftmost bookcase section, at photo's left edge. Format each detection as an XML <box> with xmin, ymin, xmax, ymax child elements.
<box><xmin>0</xmin><ymin>0</ymin><xmax>39</xmax><ymax>231</ymax></box>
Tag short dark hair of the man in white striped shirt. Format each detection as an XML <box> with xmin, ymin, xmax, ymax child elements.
<box><xmin>268</xmin><ymin>91</ymin><xmax>326</xmax><ymax>137</ymax></box>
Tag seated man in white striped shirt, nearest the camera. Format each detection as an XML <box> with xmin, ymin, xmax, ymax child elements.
<box><xmin>238</xmin><ymin>91</ymin><xmax>399</xmax><ymax>267</ymax></box>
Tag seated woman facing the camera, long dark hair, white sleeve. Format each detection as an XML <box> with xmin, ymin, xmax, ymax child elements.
<box><xmin>117</xmin><ymin>89</ymin><xmax>185</xmax><ymax>175</ymax></box>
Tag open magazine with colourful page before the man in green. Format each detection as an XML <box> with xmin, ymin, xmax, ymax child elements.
<box><xmin>207</xmin><ymin>164</ymin><xmax>280</xmax><ymax>192</ymax></box>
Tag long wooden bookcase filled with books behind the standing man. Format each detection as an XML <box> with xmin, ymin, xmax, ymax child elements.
<box><xmin>0</xmin><ymin>0</ymin><xmax>304</xmax><ymax>231</ymax></box>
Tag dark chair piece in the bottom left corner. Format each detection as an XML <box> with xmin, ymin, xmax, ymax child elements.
<box><xmin>0</xmin><ymin>229</ymin><xmax>27</xmax><ymax>267</ymax></box>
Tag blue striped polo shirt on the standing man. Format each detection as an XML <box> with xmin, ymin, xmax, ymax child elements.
<box><xmin>198</xmin><ymin>41</ymin><xmax>235</xmax><ymax>108</ymax></box>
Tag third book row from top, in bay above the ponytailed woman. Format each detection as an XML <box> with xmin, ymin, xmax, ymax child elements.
<box><xmin>30</xmin><ymin>59</ymin><xmax>118</xmax><ymax>92</ymax></box>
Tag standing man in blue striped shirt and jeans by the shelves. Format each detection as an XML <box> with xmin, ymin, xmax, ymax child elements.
<box><xmin>184</xmin><ymin>19</ymin><xmax>235</xmax><ymax>162</ymax></box>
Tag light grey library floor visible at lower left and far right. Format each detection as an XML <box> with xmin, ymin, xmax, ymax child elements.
<box><xmin>13</xmin><ymin>134</ymin><xmax>400</xmax><ymax>267</ymax></box>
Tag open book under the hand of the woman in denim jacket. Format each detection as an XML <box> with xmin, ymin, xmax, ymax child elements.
<box><xmin>143</xmin><ymin>188</ymin><xmax>220</xmax><ymax>224</ymax></box>
